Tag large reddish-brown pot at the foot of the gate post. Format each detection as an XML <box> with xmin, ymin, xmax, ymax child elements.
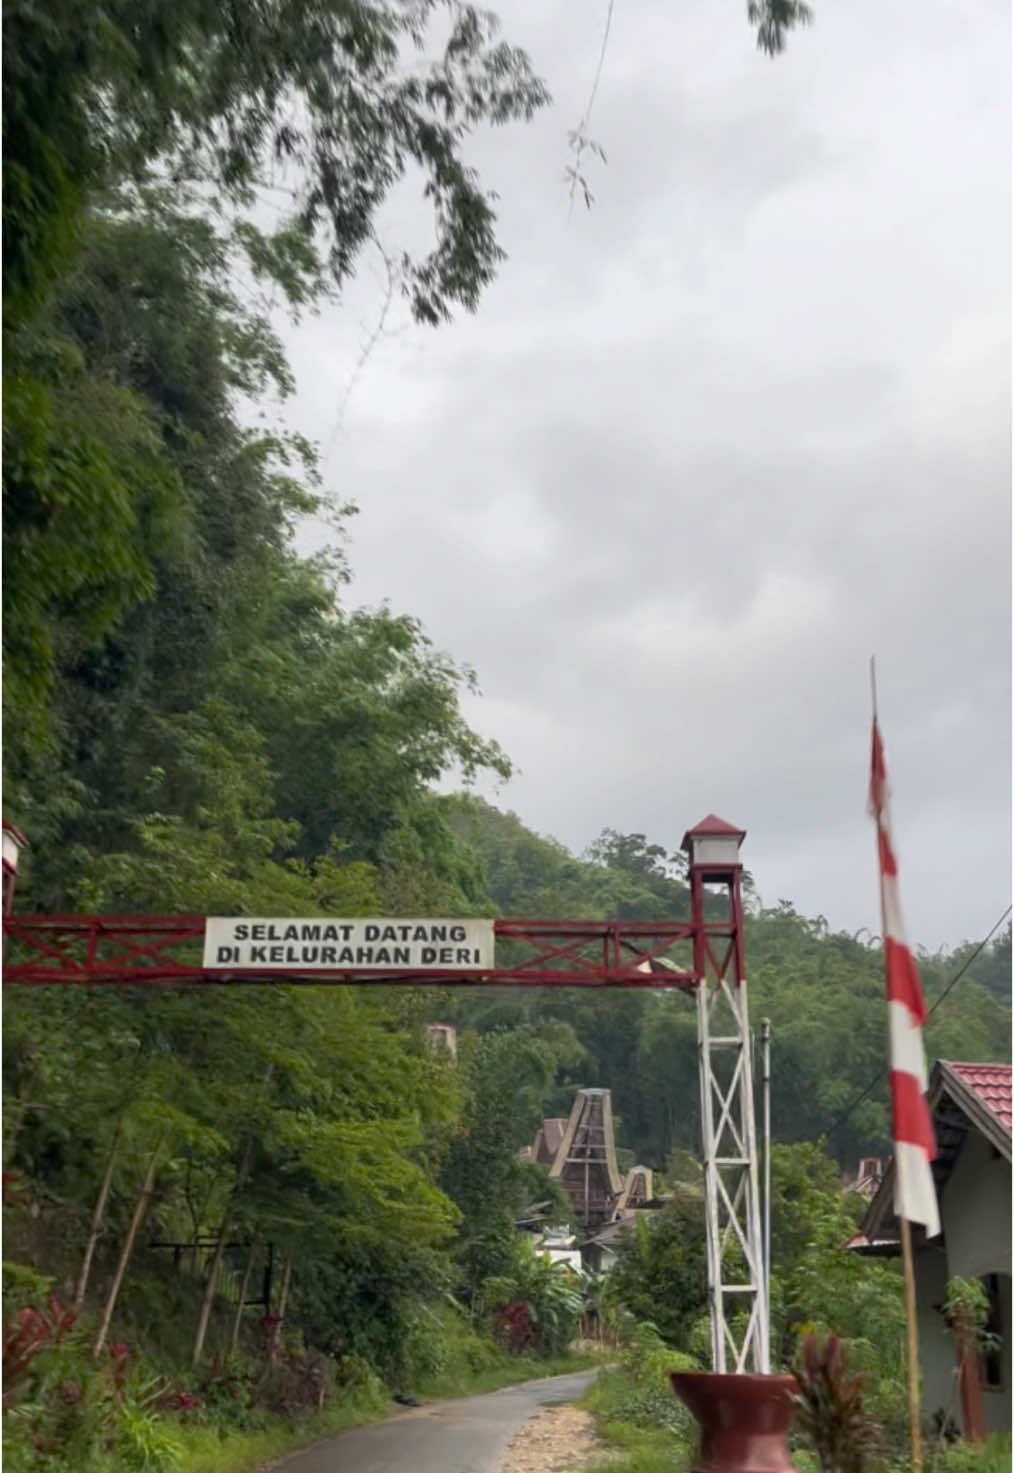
<box><xmin>671</xmin><ymin>1371</ymin><xmax>797</xmax><ymax>1473</ymax></box>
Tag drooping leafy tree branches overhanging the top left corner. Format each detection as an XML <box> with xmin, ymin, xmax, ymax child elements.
<box><xmin>3</xmin><ymin>0</ymin><xmax>548</xmax><ymax>323</ymax></box>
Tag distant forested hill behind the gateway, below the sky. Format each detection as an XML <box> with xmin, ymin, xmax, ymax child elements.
<box><xmin>439</xmin><ymin>798</ymin><xmax>1011</xmax><ymax>1167</ymax></box>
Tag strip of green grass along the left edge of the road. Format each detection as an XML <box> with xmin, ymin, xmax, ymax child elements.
<box><xmin>178</xmin><ymin>1351</ymin><xmax>603</xmax><ymax>1473</ymax></box>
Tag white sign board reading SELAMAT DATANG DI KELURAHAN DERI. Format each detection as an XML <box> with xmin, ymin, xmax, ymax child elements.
<box><xmin>203</xmin><ymin>916</ymin><xmax>494</xmax><ymax>972</ymax></box>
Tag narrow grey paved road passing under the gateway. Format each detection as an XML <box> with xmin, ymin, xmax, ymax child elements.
<box><xmin>272</xmin><ymin>1371</ymin><xmax>595</xmax><ymax>1473</ymax></box>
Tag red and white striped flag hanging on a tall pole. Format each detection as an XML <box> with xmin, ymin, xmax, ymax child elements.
<box><xmin>870</xmin><ymin>717</ymin><xmax>940</xmax><ymax>1237</ymax></box>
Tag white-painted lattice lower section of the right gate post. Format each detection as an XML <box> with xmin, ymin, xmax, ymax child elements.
<box><xmin>697</xmin><ymin>977</ymin><xmax>769</xmax><ymax>1373</ymax></box>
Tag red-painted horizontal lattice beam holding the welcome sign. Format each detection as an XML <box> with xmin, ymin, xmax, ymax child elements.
<box><xmin>3</xmin><ymin>915</ymin><xmax>704</xmax><ymax>991</ymax></box>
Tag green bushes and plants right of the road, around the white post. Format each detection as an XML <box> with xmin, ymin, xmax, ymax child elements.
<box><xmin>582</xmin><ymin>1143</ymin><xmax>1011</xmax><ymax>1473</ymax></box>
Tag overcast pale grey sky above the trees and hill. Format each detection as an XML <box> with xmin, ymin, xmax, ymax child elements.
<box><xmin>286</xmin><ymin>0</ymin><xmax>1011</xmax><ymax>949</ymax></box>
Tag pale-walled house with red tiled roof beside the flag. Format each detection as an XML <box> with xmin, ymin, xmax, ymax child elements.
<box><xmin>847</xmin><ymin>1061</ymin><xmax>1011</xmax><ymax>1436</ymax></box>
